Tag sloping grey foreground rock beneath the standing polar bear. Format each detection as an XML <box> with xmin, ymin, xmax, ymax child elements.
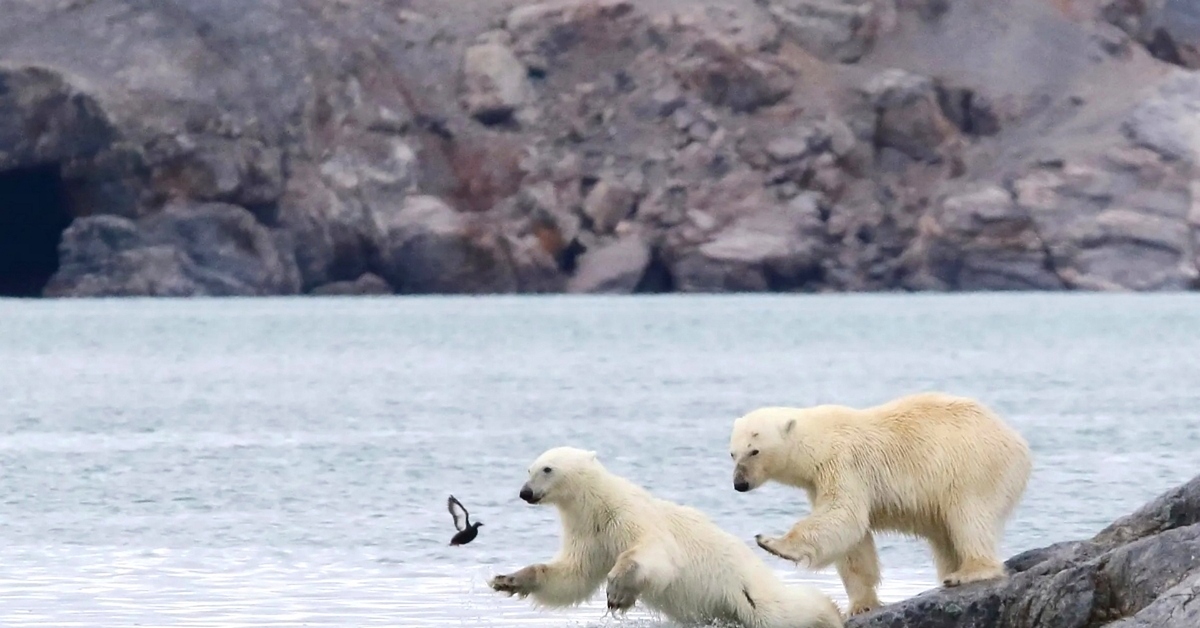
<box><xmin>846</xmin><ymin>477</ymin><xmax>1200</xmax><ymax>628</ymax></box>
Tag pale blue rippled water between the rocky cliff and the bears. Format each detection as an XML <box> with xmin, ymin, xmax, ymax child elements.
<box><xmin>0</xmin><ymin>294</ymin><xmax>1200</xmax><ymax>628</ymax></box>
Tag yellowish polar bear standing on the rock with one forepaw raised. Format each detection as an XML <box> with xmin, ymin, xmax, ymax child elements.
<box><xmin>730</xmin><ymin>393</ymin><xmax>1032</xmax><ymax>615</ymax></box>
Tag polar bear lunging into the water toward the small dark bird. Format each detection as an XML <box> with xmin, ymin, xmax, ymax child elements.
<box><xmin>490</xmin><ymin>447</ymin><xmax>842</xmax><ymax>628</ymax></box>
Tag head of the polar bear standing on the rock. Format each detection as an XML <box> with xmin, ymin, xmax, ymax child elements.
<box><xmin>730</xmin><ymin>408</ymin><xmax>797</xmax><ymax>492</ymax></box>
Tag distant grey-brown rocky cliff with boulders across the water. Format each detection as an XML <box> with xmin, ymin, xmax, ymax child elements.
<box><xmin>0</xmin><ymin>0</ymin><xmax>1200</xmax><ymax>297</ymax></box>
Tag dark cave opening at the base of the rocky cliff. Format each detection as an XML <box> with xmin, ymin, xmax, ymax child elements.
<box><xmin>0</xmin><ymin>163</ymin><xmax>72</xmax><ymax>297</ymax></box>
